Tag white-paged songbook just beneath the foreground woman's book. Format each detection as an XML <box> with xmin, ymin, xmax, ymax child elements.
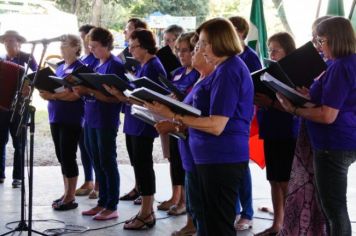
<box><xmin>131</xmin><ymin>105</ymin><xmax>186</xmax><ymax>139</ymax></box>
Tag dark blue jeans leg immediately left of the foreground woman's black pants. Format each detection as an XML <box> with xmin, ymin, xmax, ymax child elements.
<box><xmin>185</xmin><ymin>170</ymin><xmax>206</xmax><ymax>236</ymax></box>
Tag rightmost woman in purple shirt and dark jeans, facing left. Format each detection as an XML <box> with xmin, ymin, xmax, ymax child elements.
<box><xmin>277</xmin><ymin>17</ymin><xmax>356</xmax><ymax>236</ymax></box>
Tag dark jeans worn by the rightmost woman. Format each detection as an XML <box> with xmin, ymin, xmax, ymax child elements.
<box><xmin>314</xmin><ymin>150</ymin><xmax>356</xmax><ymax>236</ymax></box>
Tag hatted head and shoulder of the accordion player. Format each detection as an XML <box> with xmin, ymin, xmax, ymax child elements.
<box><xmin>0</xmin><ymin>30</ymin><xmax>38</xmax><ymax>71</ymax></box>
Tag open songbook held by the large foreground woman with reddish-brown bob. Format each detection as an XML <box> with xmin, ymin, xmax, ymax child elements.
<box><xmin>124</xmin><ymin>88</ymin><xmax>201</xmax><ymax>117</ymax></box>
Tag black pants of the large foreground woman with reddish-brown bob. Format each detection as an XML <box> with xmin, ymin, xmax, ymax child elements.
<box><xmin>197</xmin><ymin>162</ymin><xmax>248</xmax><ymax>236</ymax></box>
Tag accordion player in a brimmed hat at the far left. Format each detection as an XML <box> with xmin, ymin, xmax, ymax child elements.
<box><xmin>0</xmin><ymin>30</ymin><xmax>38</xmax><ymax>188</ymax></box>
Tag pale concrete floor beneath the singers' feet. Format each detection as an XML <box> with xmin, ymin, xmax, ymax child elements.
<box><xmin>0</xmin><ymin>164</ymin><xmax>356</xmax><ymax>236</ymax></box>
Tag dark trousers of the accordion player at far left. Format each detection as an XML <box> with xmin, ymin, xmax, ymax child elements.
<box><xmin>0</xmin><ymin>111</ymin><xmax>21</xmax><ymax>179</ymax></box>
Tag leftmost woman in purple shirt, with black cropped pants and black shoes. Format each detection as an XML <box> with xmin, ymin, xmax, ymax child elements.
<box><xmin>40</xmin><ymin>35</ymin><xmax>84</xmax><ymax>211</ymax></box>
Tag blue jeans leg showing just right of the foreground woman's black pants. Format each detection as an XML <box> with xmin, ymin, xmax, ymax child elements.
<box><xmin>236</xmin><ymin>166</ymin><xmax>253</xmax><ymax>220</ymax></box>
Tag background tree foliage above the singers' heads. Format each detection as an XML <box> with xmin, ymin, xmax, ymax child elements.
<box><xmin>55</xmin><ymin>0</ymin><xmax>209</xmax><ymax>29</ymax></box>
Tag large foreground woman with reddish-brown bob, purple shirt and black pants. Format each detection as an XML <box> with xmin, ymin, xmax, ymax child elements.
<box><xmin>147</xmin><ymin>18</ymin><xmax>253</xmax><ymax>236</ymax></box>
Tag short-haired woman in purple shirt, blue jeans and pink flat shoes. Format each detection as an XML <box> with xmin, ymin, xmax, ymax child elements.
<box><xmin>74</xmin><ymin>27</ymin><xmax>125</xmax><ymax>220</ymax></box>
